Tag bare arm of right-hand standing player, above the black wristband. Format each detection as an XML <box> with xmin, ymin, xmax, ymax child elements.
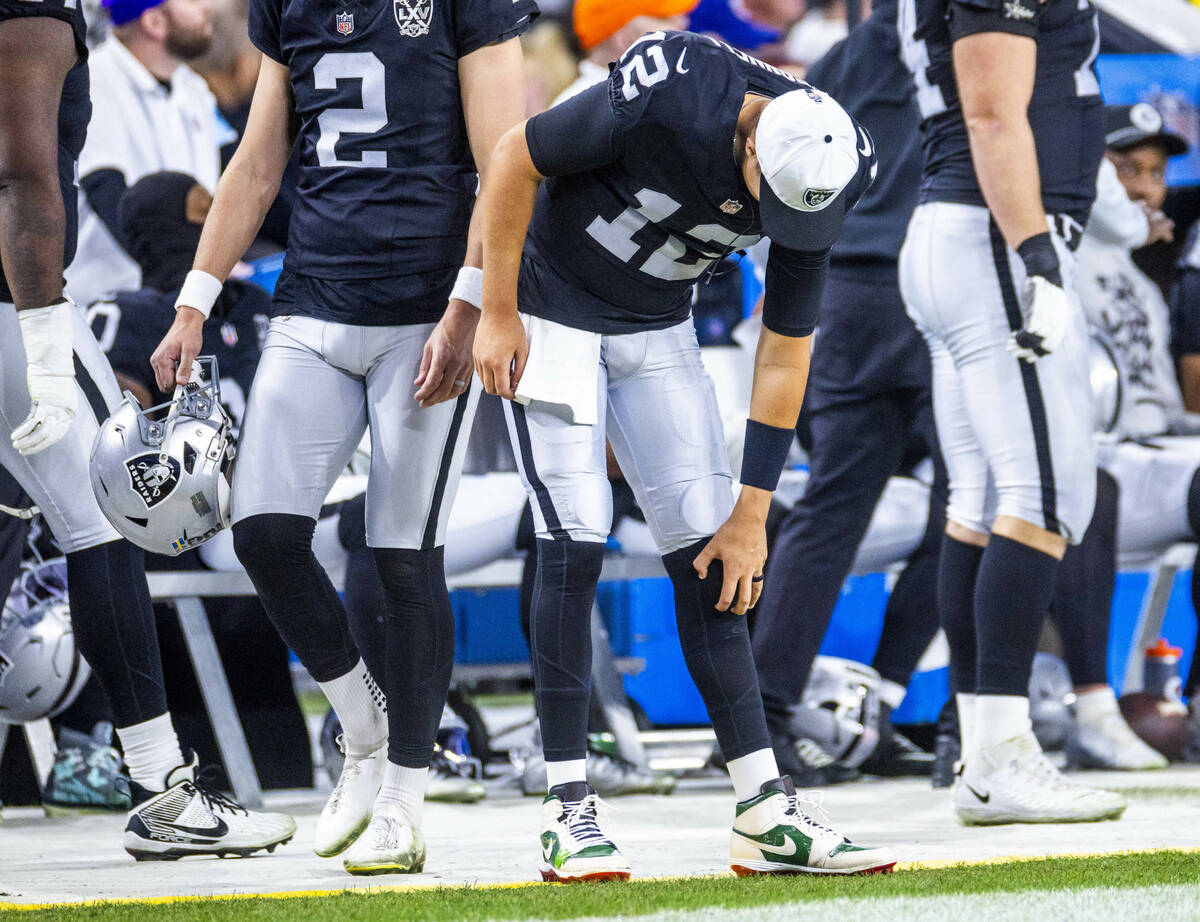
<box><xmin>954</xmin><ymin>32</ymin><xmax>1046</xmax><ymax>250</ymax></box>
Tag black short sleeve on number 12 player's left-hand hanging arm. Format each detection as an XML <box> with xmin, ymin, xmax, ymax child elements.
<box><xmin>526</xmin><ymin>80</ymin><xmax>617</xmax><ymax>176</ymax></box>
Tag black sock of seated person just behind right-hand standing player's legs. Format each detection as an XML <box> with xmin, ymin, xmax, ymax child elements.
<box><xmin>1051</xmin><ymin>471</ymin><xmax>1118</xmax><ymax>685</ymax></box>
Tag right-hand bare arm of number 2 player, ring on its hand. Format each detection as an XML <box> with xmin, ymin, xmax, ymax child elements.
<box><xmin>413</xmin><ymin>38</ymin><xmax>524</xmax><ymax>407</ymax></box>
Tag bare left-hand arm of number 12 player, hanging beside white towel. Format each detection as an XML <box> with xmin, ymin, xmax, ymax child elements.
<box><xmin>475</xmin><ymin>122</ymin><xmax>542</xmax><ymax>400</ymax></box>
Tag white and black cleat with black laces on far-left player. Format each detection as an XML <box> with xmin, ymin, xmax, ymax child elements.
<box><xmin>125</xmin><ymin>753</ymin><xmax>296</xmax><ymax>861</ymax></box>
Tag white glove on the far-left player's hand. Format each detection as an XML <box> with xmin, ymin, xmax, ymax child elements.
<box><xmin>12</xmin><ymin>300</ymin><xmax>79</xmax><ymax>455</ymax></box>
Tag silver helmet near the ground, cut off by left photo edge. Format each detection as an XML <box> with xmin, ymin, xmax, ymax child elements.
<box><xmin>0</xmin><ymin>558</ymin><xmax>91</xmax><ymax>724</ymax></box>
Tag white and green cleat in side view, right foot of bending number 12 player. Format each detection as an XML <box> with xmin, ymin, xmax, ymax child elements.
<box><xmin>730</xmin><ymin>776</ymin><xmax>896</xmax><ymax>878</ymax></box>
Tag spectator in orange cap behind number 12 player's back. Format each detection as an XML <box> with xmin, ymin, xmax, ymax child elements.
<box><xmin>554</xmin><ymin>0</ymin><xmax>698</xmax><ymax>104</ymax></box>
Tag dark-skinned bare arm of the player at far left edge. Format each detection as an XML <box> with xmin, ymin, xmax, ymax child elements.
<box><xmin>0</xmin><ymin>17</ymin><xmax>78</xmax><ymax>311</ymax></box>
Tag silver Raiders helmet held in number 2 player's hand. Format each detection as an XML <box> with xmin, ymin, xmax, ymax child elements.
<box><xmin>91</xmin><ymin>355</ymin><xmax>234</xmax><ymax>557</ymax></box>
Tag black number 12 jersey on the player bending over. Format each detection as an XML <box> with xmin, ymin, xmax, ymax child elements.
<box><xmin>518</xmin><ymin>32</ymin><xmax>874</xmax><ymax>335</ymax></box>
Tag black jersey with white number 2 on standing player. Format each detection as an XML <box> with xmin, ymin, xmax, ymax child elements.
<box><xmin>250</xmin><ymin>0</ymin><xmax>538</xmax><ymax>324</ymax></box>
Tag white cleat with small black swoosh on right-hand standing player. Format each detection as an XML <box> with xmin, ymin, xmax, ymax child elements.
<box><xmin>954</xmin><ymin>734</ymin><xmax>1126</xmax><ymax>826</ymax></box>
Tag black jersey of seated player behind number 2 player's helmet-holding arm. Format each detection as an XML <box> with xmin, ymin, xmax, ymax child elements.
<box><xmin>88</xmin><ymin>281</ymin><xmax>271</xmax><ymax>427</ymax></box>
